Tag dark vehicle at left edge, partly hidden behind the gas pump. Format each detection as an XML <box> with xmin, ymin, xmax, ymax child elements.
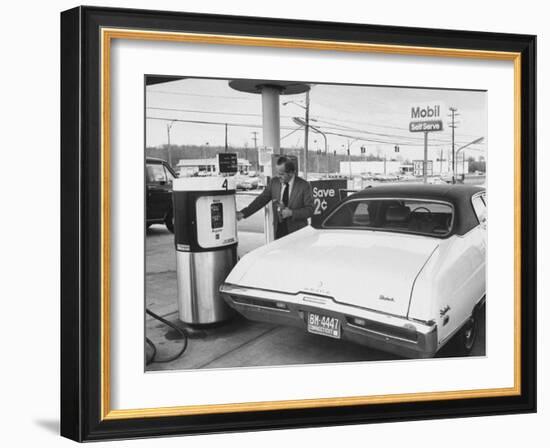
<box><xmin>145</xmin><ymin>157</ymin><xmax>177</xmax><ymax>232</ymax></box>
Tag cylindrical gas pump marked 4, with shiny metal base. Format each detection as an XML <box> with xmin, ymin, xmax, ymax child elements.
<box><xmin>173</xmin><ymin>176</ymin><xmax>238</xmax><ymax>325</ymax></box>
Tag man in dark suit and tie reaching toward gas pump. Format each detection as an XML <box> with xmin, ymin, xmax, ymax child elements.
<box><xmin>237</xmin><ymin>156</ymin><xmax>313</xmax><ymax>239</ymax></box>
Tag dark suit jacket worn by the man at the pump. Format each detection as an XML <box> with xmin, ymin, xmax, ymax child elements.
<box><xmin>241</xmin><ymin>176</ymin><xmax>313</xmax><ymax>233</ymax></box>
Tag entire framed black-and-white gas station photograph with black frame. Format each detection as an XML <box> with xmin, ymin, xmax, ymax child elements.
<box><xmin>61</xmin><ymin>7</ymin><xmax>536</xmax><ymax>441</ymax></box>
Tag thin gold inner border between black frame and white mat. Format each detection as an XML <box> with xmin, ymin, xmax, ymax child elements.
<box><xmin>100</xmin><ymin>28</ymin><xmax>521</xmax><ymax>420</ymax></box>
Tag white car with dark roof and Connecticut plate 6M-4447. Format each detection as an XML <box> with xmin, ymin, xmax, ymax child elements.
<box><xmin>220</xmin><ymin>184</ymin><xmax>487</xmax><ymax>358</ymax></box>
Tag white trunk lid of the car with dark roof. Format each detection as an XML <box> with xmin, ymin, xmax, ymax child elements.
<box><xmin>234</xmin><ymin>228</ymin><xmax>438</xmax><ymax>316</ymax></box>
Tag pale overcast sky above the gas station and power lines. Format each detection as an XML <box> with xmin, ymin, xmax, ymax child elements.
<box><xmin>146</xmin><ymin>79</ymin><xmax>487</xmax><ymax>163</ymax></box>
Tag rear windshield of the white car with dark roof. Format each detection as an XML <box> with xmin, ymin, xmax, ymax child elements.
<box><xmin>323</xmin><ymin>199</ymin><xmax>454</xmax><ymax>237</ymax></box>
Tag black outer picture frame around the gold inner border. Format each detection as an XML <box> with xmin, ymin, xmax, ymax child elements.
<box><xmin>61</xmin><ymin>7</ymin><xmax>537</xmax><ymax>441</ymax></box>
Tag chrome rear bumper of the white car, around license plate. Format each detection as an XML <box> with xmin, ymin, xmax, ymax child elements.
<box><xmin>220</xmin><ymin>283</ymin><xmax>438</xmax><ymax>358</ymax></box>
